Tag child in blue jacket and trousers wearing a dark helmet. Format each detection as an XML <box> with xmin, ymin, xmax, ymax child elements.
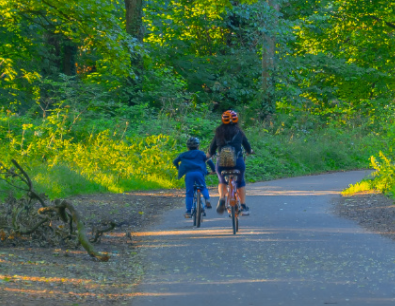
<box><xmin>173</xmin><ymin>137</ymin><xmax>215</xmax><ymax>218</ymax></box>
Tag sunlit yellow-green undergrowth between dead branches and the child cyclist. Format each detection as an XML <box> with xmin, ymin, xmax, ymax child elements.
<box><xmin>1</xmin><ymin>102</ymin><xmax>183</xmax><ymax>197</ymax></box>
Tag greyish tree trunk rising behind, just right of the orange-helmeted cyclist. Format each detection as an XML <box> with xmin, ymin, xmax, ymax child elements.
<box><xmin>262</xmin><ymin>0</ymin><xmax>280</xmax><ymax>117</ymax></box>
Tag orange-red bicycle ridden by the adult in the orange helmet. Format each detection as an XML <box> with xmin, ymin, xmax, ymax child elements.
<box><xmin>221</xmin><ymin>170</ymin><xmax>241</xmax><ymax>235</ymax></box>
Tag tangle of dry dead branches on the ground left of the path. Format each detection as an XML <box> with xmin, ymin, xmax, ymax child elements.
<box><xmin>0</xmin><ymin>160</ymin><xmax>117</xmax><ymax>261</ymax></box>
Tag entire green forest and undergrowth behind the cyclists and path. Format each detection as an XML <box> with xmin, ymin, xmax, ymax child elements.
<box><xmin>0</xmin><ymin>0</ymin><xmax>395</xmax><ymax>198</ymax></box>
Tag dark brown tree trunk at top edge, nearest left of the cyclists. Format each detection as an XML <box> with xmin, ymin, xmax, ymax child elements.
<box><xmin>124</xmin><ymin>0</ymin><xmax>144</xmax><ymax>99</ymax></box>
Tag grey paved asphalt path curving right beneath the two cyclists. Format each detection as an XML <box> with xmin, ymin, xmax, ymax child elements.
<box><xmin>132</xmin><ymin>171</ymin><xmax>395</xmax><ymax>306</ymax></box>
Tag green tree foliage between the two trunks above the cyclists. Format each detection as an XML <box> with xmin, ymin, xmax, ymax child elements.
<box><xmin>145</xmin><ymin>0</ymin><xmax>292</xmax><ymax>113</ymax></box>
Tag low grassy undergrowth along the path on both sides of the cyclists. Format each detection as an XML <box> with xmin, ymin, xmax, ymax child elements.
<box><xmin>0</xmin><ymin>109</ymin><xmax>381</xmax><ymax>198</ymax></box>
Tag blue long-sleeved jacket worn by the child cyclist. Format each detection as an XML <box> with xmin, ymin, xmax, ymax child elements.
<box><xmin>173</xmin><ymin>150</ymin><xmax>215</xmax><ymax>179</ymax></box>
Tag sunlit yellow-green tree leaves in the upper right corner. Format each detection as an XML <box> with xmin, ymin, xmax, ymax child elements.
<box><xmin>299</xmin><ymin>1</ymin><xmax>395</xmax><ymax>104</ymax></box>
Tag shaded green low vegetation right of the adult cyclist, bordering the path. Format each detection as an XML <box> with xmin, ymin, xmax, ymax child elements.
<box><xmin>246</xmin><ymin>123</ymin><xmax>381</xmax><ymax>181</ymax></box>
